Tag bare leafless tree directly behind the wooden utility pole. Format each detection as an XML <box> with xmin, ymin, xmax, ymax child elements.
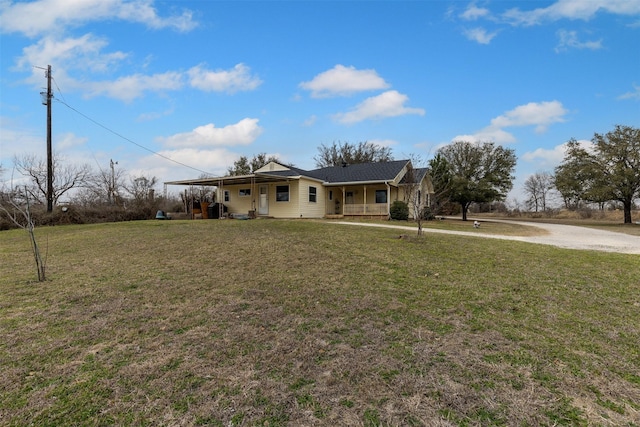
<box><xmin>14</xmin><ymin>154</ymin><xmax>92</xmax><ymax>205</ymax></box>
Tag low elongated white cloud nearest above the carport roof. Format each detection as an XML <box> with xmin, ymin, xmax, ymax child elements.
<box><xmin>158</xmin><ymin>118</ymin><xmax>263</xmax><ymax>148</ymax></box>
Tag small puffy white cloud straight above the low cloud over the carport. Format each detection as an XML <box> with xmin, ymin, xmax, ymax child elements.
<box><xmin>187</xmin><ymin>64</ymin><xmax>262</xmax><ymax>93</ymax></box>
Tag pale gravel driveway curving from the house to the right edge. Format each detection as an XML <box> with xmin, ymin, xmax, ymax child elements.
<box><xmin>336</xmin><ymin>219</ymin><xmax>640</xmax><ymax>255</ymax></box>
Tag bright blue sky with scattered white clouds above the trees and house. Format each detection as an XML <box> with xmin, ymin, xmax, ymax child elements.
<box><xmin>0</xmin><ymin>0</ymin><xmax>640</xmax><ymax>203</ymax></box>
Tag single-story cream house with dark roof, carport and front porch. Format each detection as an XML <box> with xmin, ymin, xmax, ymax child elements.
<box><xmin>165</xmin><ymin>160</ymin><xmax>433</xmax><ymax>218</ymax></box>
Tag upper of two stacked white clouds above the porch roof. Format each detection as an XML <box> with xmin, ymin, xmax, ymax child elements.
<box><xmin>300</xmin><ymin>64</ymin><xmax>389</xmax><ymax>98</ymax></box>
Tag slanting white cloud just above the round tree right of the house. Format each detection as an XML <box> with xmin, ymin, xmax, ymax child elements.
<box><xmin>453</xmin><ymin>101</ymin><xmax>568</xmax><ymax>144</ymax></box>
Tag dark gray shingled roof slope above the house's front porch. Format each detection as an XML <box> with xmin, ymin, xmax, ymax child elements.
<box><xmin>304</xmin><ymin>160</ymin><xmax>409</xmax><ymax>184</ymax></box>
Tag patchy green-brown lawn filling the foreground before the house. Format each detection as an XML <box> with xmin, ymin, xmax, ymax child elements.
<box><xmin>0</xmin><ymin>220</ymin><xmax>640</xmax><ymax>426</ymax></box>
